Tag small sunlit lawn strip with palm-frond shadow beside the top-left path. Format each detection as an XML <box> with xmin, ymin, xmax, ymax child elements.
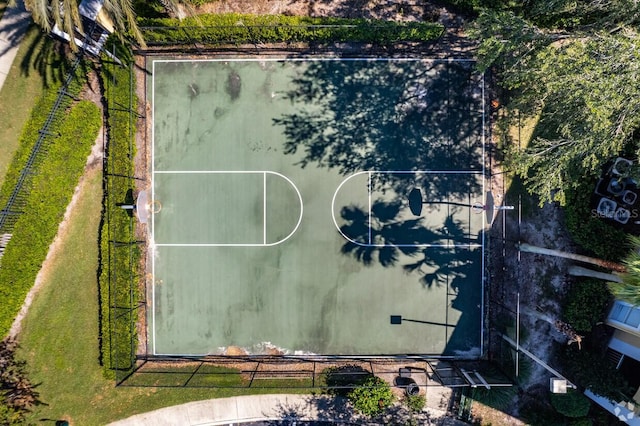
<box><xmin>0</xmin><ymin>25</ymin><xmax>57</xmax><ymax>186</ymax></box>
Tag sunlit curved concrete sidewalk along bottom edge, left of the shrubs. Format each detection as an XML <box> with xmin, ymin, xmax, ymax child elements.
<box><xmin>111</xmin><ymin>394</ymin><xmax>347</xmax><ymax>426</ymax></box>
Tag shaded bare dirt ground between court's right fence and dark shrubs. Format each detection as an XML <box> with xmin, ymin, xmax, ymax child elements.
<box><xmin>488</xmin><ymin>135</ymin><xmax>576</xmax><ymax>418</ymax></box>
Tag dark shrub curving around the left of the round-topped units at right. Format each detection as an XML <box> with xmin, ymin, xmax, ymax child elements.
<box><xmin>564</xmin><ymin>176</ymin><xmax>630</xmax><ymax>261</ymax></box>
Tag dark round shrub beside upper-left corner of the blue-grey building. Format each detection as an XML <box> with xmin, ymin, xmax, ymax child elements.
<box><xmin>562</xmin><ymin>279</ymin><xmax>612</xmax><ymax>334</ymax></box>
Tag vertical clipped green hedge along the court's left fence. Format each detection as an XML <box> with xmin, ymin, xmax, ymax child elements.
<box><xmin>99</xmin><ymin>50</ymin><xmax>141</xmax><ymax>378</ymax></box>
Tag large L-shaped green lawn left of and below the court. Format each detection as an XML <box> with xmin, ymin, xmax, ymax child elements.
<box><xmin>19</xmin><ymin>166</ymin><xmax>310</xmax><ymax>426</ymax></box>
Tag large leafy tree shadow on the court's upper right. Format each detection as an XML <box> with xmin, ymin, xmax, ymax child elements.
<box><xmin>274</xmin><ymin>61</ymin><xmax>482</xmax><ymax>199</ymax></box>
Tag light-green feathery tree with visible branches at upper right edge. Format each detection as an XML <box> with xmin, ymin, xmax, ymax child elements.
<box><xmin>507</xmin><ymin>31</ymin><xmax>640</xmax><ymax>204</ymax></box>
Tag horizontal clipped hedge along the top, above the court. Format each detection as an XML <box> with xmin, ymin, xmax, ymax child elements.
<box><xmin>139</xmin><ymin>13</ymin><xmax>444</xmax><ymax>46</ymax></box>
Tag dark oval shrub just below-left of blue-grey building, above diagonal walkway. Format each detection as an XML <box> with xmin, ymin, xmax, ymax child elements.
<box><xmin>562</xmin><ymin>345</ymin><xmax>633</xmax><ymax>401</ymax></box>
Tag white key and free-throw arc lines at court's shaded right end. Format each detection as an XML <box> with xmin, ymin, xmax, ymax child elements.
<box><xmin>331</xmin><ymin>171</ymin><xmax>484</xmax><ymax>250</ymax></box>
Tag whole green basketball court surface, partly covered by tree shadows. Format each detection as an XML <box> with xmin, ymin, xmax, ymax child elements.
<box><xmin>147</xmin><ymin>59</ymin><xmax>487</xmax><ymax>357</ymax></box>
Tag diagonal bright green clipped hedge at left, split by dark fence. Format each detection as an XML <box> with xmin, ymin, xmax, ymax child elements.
<box><xmin>0</xmin><ymin>91</ymin><xmax>101</xmax><ymax>336</ymax></box>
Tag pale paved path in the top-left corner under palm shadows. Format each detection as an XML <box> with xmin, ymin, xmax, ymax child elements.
<box><xmin>0</xmin><ymin>0</ymin><xmax>31</xmax><ymax>89</ymax></box>
